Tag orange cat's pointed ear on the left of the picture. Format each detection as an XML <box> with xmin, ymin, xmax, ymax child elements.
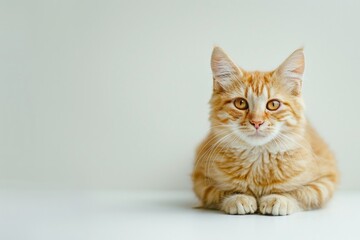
<box><xmin>211</xmin><ymin>46</ymin><xmax>243</xmax><ymax>90</ymax></box>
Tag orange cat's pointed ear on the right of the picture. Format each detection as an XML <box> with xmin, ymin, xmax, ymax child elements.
<box><xmin>275</xmin><ymin>48</ymin><xmax>305</xmax><ymax>96</ymax></box>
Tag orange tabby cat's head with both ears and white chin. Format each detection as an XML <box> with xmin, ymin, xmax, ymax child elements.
<box><xmin>210</xmin><ymin>47</ymin><xmax>304</xmax><ymax>146</ymax></box>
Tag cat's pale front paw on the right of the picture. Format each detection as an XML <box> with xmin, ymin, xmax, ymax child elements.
<box><xmin>259</xmin><ymin>194</ymin><xmax>300</xmax><ymax>216</ymax></box>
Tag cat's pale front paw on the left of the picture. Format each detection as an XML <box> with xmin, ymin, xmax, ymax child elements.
<box><xmin>221</xmin><ymin>194</ymin><xmax>257</xmax><ymax>214</ymax></box>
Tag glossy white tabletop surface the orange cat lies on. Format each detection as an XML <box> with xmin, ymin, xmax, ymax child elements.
<box><xmin>0</xmin><ymin>191</ymin><xmax>360</xmax><ymax>240</ymax></box>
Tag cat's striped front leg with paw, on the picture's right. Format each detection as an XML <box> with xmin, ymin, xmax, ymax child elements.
<box><xmin>259</xmin><ymin>175</ymin><xmax>336</xmax><ymax>215</ymax></box>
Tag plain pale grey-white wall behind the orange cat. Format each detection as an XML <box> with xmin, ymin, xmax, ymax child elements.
<box><xmin>0</xmin><ymin>0</ymin><xmax>360</xmax><ymax>190</ymax></box>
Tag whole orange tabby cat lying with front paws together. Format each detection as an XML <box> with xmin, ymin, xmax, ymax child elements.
<box><xmin>192</xmin><ymin>47</ymin><xmax>338</xmax><ymax>215</ymax></box>
